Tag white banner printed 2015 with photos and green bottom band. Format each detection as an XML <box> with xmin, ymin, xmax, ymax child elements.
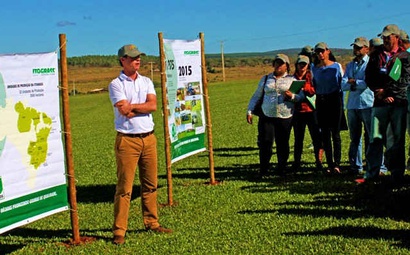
<box><xmin>164</xmin><ymin>39</ymin><xmax>206</xmax><ymax>163</ymax></box>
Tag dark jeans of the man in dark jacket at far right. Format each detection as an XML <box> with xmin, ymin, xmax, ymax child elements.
<box><xmin>365</xmin><ymin>105</ymin><xmax>407</xmax><ymax>179</ymax></box>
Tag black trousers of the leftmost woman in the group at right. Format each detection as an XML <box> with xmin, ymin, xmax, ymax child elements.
<box><xmin>258</xmin><ymin>116</ymin><xmax>292</xmax><ymax>174</ymax></box>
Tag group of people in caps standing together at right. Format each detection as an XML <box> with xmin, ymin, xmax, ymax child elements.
<box><xmin>247</xmin><ymin>24</ymin><xmax>410</xmax><ymax>183</ymax></box>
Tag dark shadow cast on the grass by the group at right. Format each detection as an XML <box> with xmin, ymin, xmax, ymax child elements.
<box><xmin>238</xmin><ymin>165</ymin><xmax>410</xmax><ymax>249</ymax></box>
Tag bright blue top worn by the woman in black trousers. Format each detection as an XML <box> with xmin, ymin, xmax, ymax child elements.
<box><xmin>312</xmin><ymin>62</ymin><xmax>343</xmax><ymax>95</ymax></box>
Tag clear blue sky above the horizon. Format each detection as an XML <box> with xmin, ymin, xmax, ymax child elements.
<box><xmin>0</xmin><ymin>0</ymin><xmax>410</xmax><ymax>57</ymax></box>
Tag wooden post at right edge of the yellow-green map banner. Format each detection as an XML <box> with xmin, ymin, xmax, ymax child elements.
<box><xmin>59</xmin><ymin>34</ymin><xmax>80</xmax><ymax>244</ymax></box>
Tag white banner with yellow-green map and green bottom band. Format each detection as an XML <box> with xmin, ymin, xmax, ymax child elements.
<box><xmin>0</xmin><ymin>52</ymin><xmax>68</xmax><ymax>234</ymax></box>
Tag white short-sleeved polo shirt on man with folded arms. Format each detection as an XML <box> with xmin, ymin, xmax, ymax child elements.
<box><xmin>108</xmin><ymin>71</ymin><xmax>156</xmax><ymax>134</ymax></box>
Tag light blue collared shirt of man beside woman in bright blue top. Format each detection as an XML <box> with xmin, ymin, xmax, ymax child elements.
<box><xmin>342</xmin><ymin>55</ymin><xmax>374</xmax><ymax>109</ymax></box>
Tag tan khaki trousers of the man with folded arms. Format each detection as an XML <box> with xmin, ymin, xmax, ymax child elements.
<box><xmin>113</xmin><ymin>134</ymin><xmax>159</xmax><ymax>236</ymax></box>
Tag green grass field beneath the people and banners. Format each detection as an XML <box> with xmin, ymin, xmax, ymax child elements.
<box><xmin>0</xmin><ymin>80</ymin><xmax>410</xmax><ymax>254</ymax></box>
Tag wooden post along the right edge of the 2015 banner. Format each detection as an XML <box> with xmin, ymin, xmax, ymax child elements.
<box><xmin>199</xmin><ymin>33</ymin><xmax>217</xmax><ymax>185</ymax></box>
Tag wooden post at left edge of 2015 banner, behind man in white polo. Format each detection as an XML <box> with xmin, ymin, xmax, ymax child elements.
<box><xmin>158</xmin><ymin>32</ymin><xmax>174</xmax><ymax>206</ymax></box>
